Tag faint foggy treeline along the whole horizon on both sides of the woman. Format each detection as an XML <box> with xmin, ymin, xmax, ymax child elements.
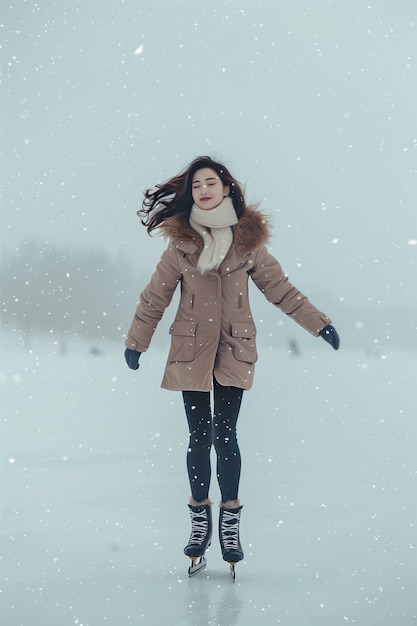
<box><xmin>0</xmin><ymin>240</ymin><xmax>410</xmax><ymax>356</ymax></box>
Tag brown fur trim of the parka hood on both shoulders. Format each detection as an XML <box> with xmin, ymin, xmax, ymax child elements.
<box><xmin>159</xmin><ymin>207</ymin><xmax>271</xmax><ymax>254</ymax></box>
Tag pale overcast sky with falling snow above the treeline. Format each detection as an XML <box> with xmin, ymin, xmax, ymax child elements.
<box><xmin>1</xmin><ymin>0</ymin><xmax>417</xmax><ymax>342</ymax></box>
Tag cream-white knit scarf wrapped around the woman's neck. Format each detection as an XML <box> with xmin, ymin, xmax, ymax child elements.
<box><xmin>190</xmin><ymin>196</ymin><xmax>238</xmax><ymax>274</ymax></box>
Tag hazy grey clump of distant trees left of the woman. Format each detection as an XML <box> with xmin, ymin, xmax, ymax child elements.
<box><xmin>0</xmin><ymin>240</ymin><xmax>143</xmax><ymax>345</ymax></box>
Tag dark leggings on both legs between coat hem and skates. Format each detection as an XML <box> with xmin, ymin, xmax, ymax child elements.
<box><xmin>182</xmin><ymin>379</ymin><xmax>243</xmax><ymax>502</ymax></box>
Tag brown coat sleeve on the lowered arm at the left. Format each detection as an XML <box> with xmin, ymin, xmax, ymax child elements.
<box><xmin>125</xmin><ymin>246</ymin><xmax>181</xmax><ymax>352</ymax></box>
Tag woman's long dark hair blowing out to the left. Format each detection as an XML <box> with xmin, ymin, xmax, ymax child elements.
<box><xmin>137</xmin><ymin>156</ymin><xmax>246</xmax><ymax>235</ymax></box>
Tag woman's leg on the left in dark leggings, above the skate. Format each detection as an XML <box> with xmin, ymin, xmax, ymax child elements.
<box><xmin>182</xmin><ymin>391</ymin><xmax>212</xmax><ymax>504</ymax></box>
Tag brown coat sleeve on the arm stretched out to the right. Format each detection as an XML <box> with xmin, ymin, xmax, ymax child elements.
<box><xmin>249</xmin><ymin>246</ymin><xmax>331</xmax><ymax>337</ymax></box>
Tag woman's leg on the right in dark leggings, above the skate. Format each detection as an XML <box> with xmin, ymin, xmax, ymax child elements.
<box><xmin>213</xmin><ymin>379</ymin><xmax>243</xmax><ymax>503</ymax></box>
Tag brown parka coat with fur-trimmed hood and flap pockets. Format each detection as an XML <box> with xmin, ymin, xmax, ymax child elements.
<box><xmin>125</xmin><ymin>208</ymin><xmax>331</xmax><ymax>391</ymax></box>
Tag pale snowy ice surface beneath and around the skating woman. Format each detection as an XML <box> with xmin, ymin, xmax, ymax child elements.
<box><xmin>0</xmin><ymin>336</ymin><xmax>417</xmax><ymax>626</ymax></box>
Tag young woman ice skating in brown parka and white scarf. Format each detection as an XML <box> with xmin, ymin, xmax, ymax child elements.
<box><xmin>125</xmin><ymin>157</ymin><xmax>339</xmax><ymax>579</ymax></box>
